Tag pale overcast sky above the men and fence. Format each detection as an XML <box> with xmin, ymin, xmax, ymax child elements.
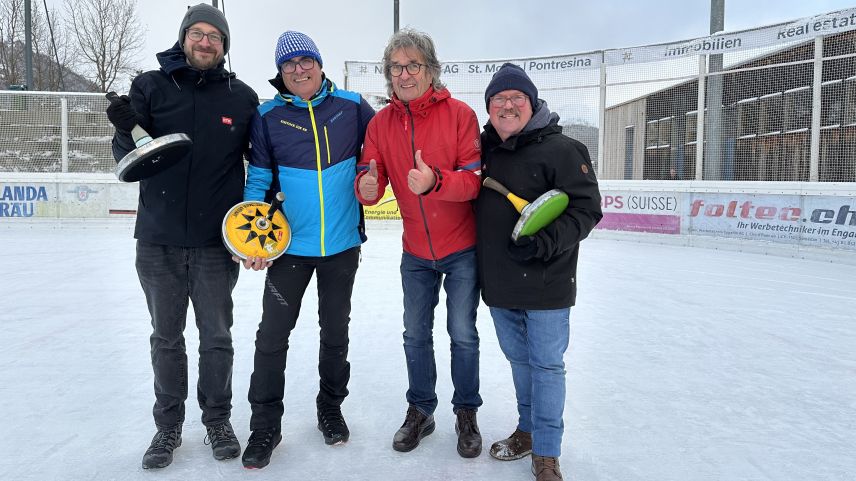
<box><xmin>49</xmin><ymin>0</ymin><xmax>854</xmax><ymax>93</ymax></box>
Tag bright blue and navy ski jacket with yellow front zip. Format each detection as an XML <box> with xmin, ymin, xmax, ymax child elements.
<box><xmin>244</xmin><ymin>78</ymin><xmax>374</xmax><ymax>257</ymax></box>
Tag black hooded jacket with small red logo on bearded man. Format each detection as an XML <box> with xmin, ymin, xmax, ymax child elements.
<box><xmin>113</xmin><ymin>43</ymin><xmax>259</xmax><ymax>247</ymax></box>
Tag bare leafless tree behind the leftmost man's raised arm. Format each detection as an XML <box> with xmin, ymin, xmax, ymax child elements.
<box><xmin>65</xmin><ymin>0</ymin><xmax>145</xmax><ymax>92</ymax></box>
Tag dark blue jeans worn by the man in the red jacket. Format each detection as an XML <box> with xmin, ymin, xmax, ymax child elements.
<box><xmin>401</xmin><ymin>249</ymin><xmax>482</xmax><ymax>415</ymax></box>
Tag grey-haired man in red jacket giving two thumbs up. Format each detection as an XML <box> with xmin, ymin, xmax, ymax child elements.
<box><xmin>355</xmin><ymin>29</ymin><xmax>482</xmax><ymax>458</ymax></box>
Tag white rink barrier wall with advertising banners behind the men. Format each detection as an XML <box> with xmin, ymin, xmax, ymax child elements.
<box><xmin>0</xmin><ymin>172</ymin><xmax>856</xmax><ymax>264</ymax></box>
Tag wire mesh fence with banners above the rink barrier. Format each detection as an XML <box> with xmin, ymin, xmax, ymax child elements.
<box><xmin>0</xmin><ymin>8</ymin><xmax>856</xmax><ymax>182</ymax></box>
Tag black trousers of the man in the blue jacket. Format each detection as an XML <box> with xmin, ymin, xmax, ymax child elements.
<box><xmin>248</xmin><ymin>247</ymin><xmax>360</xmax><ymax>430</ymax></box>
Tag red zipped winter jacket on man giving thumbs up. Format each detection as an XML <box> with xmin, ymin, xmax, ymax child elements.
<box><xmin>354</xmin><ymin>88</ymin><xmax>481</xmax><ymax>260</ymax></box>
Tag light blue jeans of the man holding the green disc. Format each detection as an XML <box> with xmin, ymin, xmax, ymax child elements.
<box><xmin>490</xmin><ymin>307</ymin><xmax>571</xmax><ymax>457</ymax></box>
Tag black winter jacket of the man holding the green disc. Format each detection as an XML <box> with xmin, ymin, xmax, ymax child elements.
<box><xmin>476</xmin><ymin>117</ymin><xmax>603</xmax><ymax>309</ymax></box>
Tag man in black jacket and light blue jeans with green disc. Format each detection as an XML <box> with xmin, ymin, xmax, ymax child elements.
<box><xmin>476</xmin><ymin>63</ymin><xmax>602</xmax><ymax>481</ymax></box>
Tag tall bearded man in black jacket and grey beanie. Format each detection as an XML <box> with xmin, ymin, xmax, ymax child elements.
<box><xmin>107</xmin><ymin>4</ymin><xmax>258</xmax><ymax>469</ymax></box>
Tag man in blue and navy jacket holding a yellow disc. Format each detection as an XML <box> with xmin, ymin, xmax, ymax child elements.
<box><xmin>243</xmin><ymin>31</ymin><xmax>374</xmax><ymax>468</ymax></box>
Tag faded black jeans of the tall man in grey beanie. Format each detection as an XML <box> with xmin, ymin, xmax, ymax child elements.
<box><xmin>136</xmin><ymin>240</ymin><xmax>239</xmax><ymax>428</ymax></box>
